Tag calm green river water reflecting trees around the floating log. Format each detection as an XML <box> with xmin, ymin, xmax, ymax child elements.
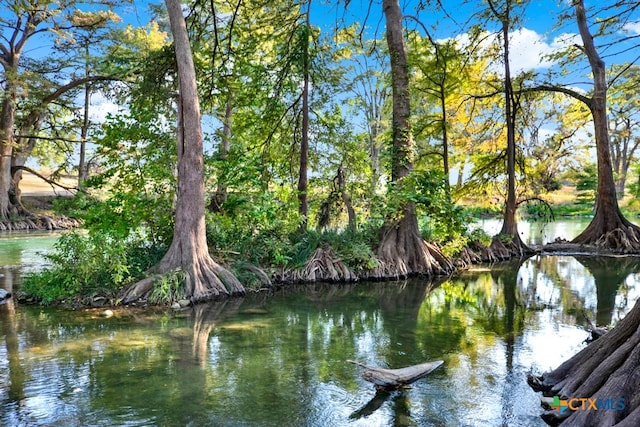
<box><xmin>0</xmin><ymin>224</ymin><xmax>640</xmax><ymax>426</ymax></box>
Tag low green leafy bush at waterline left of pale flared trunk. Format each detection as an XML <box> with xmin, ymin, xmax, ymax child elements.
<box><xmin>21</xmin><ymin>232</ymin><xmax>164</xmax><ymax>304</ymax></box>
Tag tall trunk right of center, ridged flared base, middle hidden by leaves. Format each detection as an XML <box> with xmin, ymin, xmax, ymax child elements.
<box><xmin>373</xmin><ymin>0</ymin><xmax>453</xmax><ymax>277</ymax></box>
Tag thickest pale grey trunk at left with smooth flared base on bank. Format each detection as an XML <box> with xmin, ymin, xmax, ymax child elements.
<box><xmin>123</xmin><ymin>0</ymin><xmax>244</xmax><ymax>303</ymax></box>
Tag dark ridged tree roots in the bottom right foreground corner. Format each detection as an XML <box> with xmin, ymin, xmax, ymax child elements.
<box><xmin>528</xmin><ymin>300</ymin><xmax>640</xmax><ymax>427</ymax></box>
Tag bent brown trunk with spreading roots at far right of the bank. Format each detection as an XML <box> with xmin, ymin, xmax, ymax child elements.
<box><xmin>573</xmin><ymin>0</ymin><xmax>640</xmax><ymax>251</ymax></box>
